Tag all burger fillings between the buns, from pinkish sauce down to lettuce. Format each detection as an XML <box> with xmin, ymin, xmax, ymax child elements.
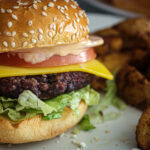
<box><xmin>0</xmin><ymin>38</ymin><xmax>113</xmax><ymax>122</ymax></box>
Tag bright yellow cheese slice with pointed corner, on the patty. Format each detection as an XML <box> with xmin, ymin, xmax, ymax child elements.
<box><xmin>0</xmin><ymin>60</ymin><xmax>113</xmax><ymax>79</ymax></box>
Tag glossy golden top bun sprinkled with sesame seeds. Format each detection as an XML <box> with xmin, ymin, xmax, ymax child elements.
<box><xmin>0</xmin><ymin>0</ymin><xmax>88</xmax><ymax>53</ymax></box>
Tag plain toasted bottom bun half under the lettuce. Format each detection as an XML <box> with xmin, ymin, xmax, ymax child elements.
<box><xmin>0</xmin><ymin>101</ymin><xmax>87</xmax><ymax>144</ymax></box>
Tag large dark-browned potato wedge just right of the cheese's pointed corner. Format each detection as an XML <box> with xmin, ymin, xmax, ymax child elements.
<box><xmin>116</xmin><ymin>65</ymin><xmax>150</xmax><ymax>109</ymax></box>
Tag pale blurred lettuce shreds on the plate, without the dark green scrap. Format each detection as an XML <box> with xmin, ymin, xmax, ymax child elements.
<box><xmin>88</xmin><ymin>75</ymin><xmax>127</xmax><ymax>122</ymax></box>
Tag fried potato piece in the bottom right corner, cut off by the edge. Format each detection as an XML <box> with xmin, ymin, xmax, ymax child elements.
<box><xmin>136</xmin><ymin>107</ymin><xmax>150</xmax><ymax>150</ymax></box>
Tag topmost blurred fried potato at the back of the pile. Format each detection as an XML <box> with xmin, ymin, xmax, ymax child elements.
<box><xmin>113</xmin><ymin>17</ymin><xmax>150</xmax><ymax>48</ymax></box>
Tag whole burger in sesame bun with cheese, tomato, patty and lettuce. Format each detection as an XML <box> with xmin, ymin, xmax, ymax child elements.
<box><xmin>0</xmin><ymin>0</ymin><xmax>112</xmax><ymax>144</ymax></box>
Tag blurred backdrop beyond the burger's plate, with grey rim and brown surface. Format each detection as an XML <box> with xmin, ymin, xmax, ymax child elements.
<box><xmin>77</xmin><ymin>0</ymin><xmax>150</xmax><ymax>18</ymax></box>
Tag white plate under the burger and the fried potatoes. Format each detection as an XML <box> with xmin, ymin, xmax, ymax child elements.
<box><xmin>0</xmin><ymin>14</ymin><xmax>141</xmax><ymax>150</ymax></box>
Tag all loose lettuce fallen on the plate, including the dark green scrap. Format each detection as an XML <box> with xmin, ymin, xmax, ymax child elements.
<box><xmin>73</xmin><ymin>73</ymin><xmax>127</xmax><ymax>132</ymax></box>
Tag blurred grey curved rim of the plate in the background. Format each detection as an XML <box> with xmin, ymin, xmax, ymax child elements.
<box><xmin>83</xmin><ymin>0</ymin><xmax>140</xmax><ymax>17</ymax></box>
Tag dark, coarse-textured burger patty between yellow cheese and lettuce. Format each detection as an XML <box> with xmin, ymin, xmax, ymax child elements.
<box><xmin>0</xmin><ymin>72</ymin><xmax>94</xmax><ymax>100</ymax></box>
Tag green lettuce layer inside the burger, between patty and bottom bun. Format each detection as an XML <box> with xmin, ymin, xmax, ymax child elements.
<box><xmin>0</xmin><ymin>86</ymin><xmax>100</xmax><ymax>122</ymax></box>
